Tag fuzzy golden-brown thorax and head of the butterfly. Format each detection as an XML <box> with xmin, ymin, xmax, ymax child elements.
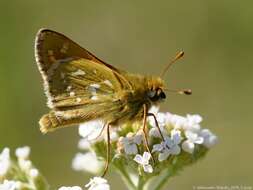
<box><xmin>107</xmin><ymin>74</ymin><xmax>166</xmax><ymax>125</ymax></box>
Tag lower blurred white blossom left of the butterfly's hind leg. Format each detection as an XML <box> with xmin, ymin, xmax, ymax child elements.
<box><xmin>72</xmin><ymin>152</ymin><xmax>104</xmax><ymax>174</ymax></box>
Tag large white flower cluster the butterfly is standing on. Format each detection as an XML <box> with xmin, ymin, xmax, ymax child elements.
<box><xmin>72</xmin><ymin>109</ymin><xmax>218</xmax><ymax>190</ymax></box>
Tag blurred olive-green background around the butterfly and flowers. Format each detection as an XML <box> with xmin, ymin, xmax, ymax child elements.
<box><xmin>0</xmin><ymin>0</ymin><xmax>253</xmax><ymax>190</ymax></box>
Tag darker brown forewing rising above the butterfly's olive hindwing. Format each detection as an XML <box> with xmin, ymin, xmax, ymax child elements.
<box><xmin>35</xmin><ymin>29</ymin><xmax>118</xmax><ymax>72</ymax></box>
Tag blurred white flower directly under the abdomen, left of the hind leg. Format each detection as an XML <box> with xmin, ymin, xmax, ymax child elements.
<box><xmin>79</xmin><ymin>120</ymin><xmax>104</xmax><ymax>141</ymax></box>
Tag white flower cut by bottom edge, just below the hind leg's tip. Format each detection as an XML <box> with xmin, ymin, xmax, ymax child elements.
<box><xmin>85</xmin><ymin>177</ymin><xmax>110</xmax><ymax>190</ymax></box>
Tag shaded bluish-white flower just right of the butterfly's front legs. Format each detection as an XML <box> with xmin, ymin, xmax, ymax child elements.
<box><xmin>152</xmin><ymin>129</ymin><xmax>182</xmax><ymax>162</ymax></box>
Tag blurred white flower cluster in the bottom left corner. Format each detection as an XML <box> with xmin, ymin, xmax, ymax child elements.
<box><xmin>0</xmin><ymin>146</ymin><xmax>49</xmax><ymax>190</ymax></box>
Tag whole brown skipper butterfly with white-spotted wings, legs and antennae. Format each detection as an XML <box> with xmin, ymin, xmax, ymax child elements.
<box><xmin>35</xmin><ymin>29</ymin><xmax>191</xmax><ymax>176</ymax></box>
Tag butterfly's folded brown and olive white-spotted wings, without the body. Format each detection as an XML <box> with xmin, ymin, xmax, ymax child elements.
<box><xmin>35</xmin><ymin>29</ymin><xmax>131</xmax><ymax>110</ymax></box>
